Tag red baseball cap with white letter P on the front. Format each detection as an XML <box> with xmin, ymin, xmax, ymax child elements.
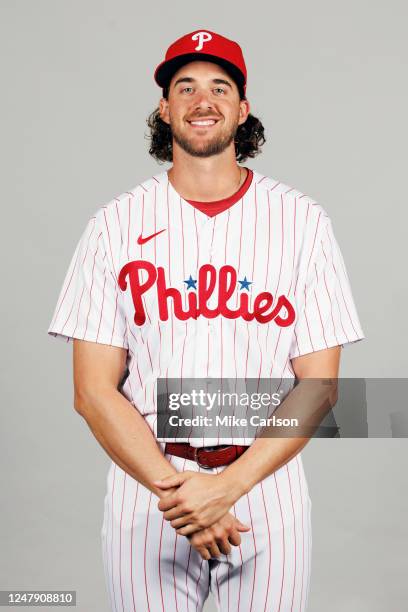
<box><xmin>154</xmin><ymin>30</ymin><xmax>247</xmax><ymax>95</ymax></box>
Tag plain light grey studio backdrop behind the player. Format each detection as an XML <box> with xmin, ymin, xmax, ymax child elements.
<box><xmin>0</xmin><ymin>0</ymin><xmax>408</xmax><ymax>612</ymax></box>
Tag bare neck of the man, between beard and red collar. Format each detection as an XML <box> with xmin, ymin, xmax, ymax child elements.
<box><xmin>168</xmin><ymin>146</ymin><xmax>246</xmax><ymax>202</ymax></box>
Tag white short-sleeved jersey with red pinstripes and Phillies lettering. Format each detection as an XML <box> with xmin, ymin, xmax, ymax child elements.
<box><xmin>48</xmin><ymin>172</ymin><xmax>365</xmax><ymax>446</ymax></box>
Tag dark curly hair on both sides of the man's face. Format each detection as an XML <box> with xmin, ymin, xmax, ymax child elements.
<box><xmin>146</xmin><ymin>97</ymin><xmax>266</xmax><ymax>162</ymax></box>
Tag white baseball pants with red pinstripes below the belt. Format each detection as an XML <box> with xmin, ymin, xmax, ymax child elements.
<box><xmin>101</xmin><ymin>454</ymin><xmax>311</xmax><ymax>612</ymax></box>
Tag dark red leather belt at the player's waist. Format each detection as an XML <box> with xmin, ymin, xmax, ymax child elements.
<box><xmin>164</xmin><ymin>442</ymin><xmax>249</xmax><ymax>469</ymax></box>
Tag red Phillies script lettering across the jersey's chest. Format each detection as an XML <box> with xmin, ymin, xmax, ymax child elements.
<box><xmin>118</xmin><ymin>259</ymin><xmax>295</xmax><ymax>327</ymax></box>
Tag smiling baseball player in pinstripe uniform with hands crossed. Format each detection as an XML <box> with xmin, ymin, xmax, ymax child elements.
<box><xmin>48</xmin><ymin>30</ymin><xmax>364</xmax><ymax>612</ymax></box>
